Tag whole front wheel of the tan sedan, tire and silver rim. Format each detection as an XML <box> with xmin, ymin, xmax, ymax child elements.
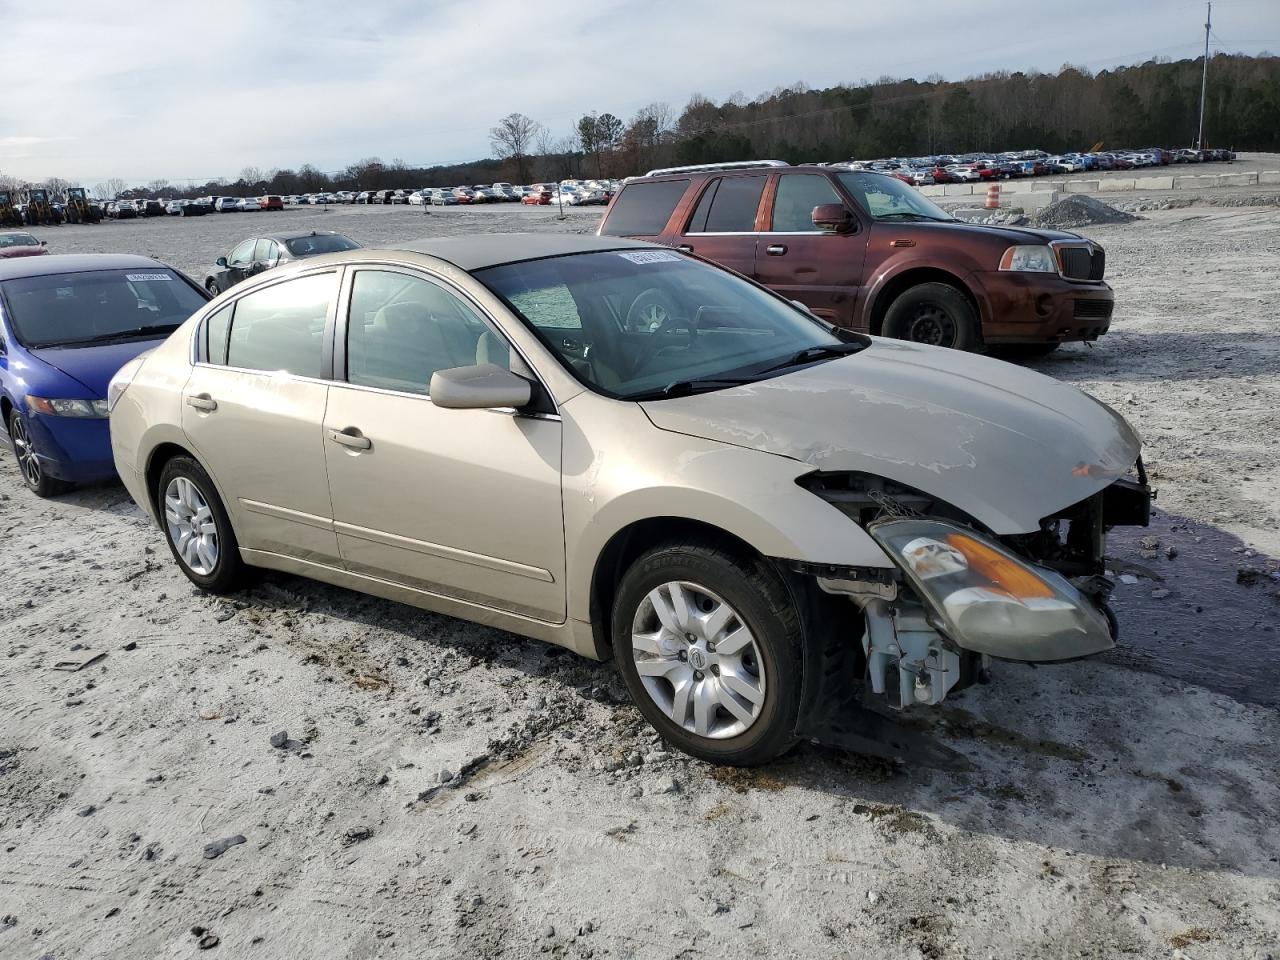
<box><xmin>612</xmin><ymin>541</ymin><xmax>801</xmax><ymax>765</ymax></box>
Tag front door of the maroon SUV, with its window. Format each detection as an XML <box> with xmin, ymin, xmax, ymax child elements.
<box><xmin>755</xmin><ymin>173</ymin><xmax>869</xmax><ymax>326</ymax></box>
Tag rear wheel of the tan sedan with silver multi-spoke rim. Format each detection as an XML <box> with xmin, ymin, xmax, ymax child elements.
<box><xmin>157</xmin><ymin>457</ymin><xmax>244</xmax><ymax>594</ymax></box>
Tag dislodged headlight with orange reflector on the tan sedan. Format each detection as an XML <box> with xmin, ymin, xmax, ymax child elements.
<box><xmin>868</xmin><ymin>520</ymin><xmax>1115</xmax><ymax>662</ymax></box>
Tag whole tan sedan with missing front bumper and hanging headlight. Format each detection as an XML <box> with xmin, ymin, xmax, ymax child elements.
<box><xmin>109</xmin><ymin>236</ymin><xmax>1149</xmax><ymax>764</ymax></box>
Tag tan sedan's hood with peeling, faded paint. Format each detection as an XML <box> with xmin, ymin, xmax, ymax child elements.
<box><xmin>641</xmin><ymin>338</ymin><xmax>1142</xmax><ymax>534</ymax></box>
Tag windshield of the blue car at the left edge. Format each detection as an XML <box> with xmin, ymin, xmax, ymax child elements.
<box><xmin>0</xmin><ymin>266</ymin><xmax>205</xmax><ymax>348</ymax></box>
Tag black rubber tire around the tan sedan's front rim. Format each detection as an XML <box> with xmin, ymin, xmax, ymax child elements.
<box><xmin>612</xmin><ymin>541</ymin><xmax>803</xmax><ymax>767</ymax></box>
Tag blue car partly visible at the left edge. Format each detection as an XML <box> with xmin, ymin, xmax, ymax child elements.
<box><xmin>0</xmin><ymin>253</ymin><xmax>209</xmax><ymax>497</ymax></box>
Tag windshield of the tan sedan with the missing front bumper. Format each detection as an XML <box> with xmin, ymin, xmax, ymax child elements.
<box><xmin>475</xmin><ymin>250</ymin><xmax>856</xmax><ymax>399</ymax></box>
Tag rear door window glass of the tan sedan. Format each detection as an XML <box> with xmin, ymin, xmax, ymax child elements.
<box><xmin>227</xmin><ymin>274</ymin><xmax>337</xmax><ymax>376</ymax></box>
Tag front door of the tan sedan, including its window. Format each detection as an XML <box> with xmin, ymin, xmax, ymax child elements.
<box><xmin>324</xmin><ymin>266</ymin><xmax>566</xmax><ymax>622</ymax></box>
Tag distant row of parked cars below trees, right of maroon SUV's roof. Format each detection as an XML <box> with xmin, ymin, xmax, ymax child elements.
<box><xmin>829</xmin><ymin>147</ymin><xmax>1235</xmax><ymax>187</ymax></box>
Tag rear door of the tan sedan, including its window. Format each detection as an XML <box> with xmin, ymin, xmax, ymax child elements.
<box><xmin>182</xmin><ymin>270</ymin><xmax>339</xmax><ymax>566</ymax></box>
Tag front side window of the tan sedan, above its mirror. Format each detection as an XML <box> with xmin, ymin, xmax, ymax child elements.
<box><xmin>347</xmin><ymin>270</ymin><xmax>511</xmax><ymax>396</ymax></box>
